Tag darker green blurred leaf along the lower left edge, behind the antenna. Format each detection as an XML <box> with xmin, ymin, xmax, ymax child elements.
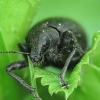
<box><xmin>0</xmin><ymin>33</ymin><xmax>19</xmax><ymax>100</ymax></box>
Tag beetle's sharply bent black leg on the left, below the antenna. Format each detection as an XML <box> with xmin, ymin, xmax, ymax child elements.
<box><xmin>6</xmin><ymin>61</ymin><xmax>41</xmax><ymax>100</ymax></box>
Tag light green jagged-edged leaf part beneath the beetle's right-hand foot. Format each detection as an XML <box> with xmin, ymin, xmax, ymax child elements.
<box><xmin>30</xmin><ymin>58</ymin><xmax>80</xmax><ymax>100</ymax></box>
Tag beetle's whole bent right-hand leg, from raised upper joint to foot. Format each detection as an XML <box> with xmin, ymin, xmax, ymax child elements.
<box><xmin>59</xmin><ymin>31</ymin><xmax>84</xmax><ymax>88</ymax></box>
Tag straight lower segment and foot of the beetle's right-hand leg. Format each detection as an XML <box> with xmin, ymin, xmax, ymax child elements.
<box><xmin>59</xmin><ymin>48</ymin><xmax>77</xmax><ymax>88</ymax></box>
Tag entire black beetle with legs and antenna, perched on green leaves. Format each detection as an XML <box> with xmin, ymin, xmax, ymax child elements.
<box><xmin>0</xmin><ymin>18</ymin><xmax>87</xmax><ymax>100</ymax></box>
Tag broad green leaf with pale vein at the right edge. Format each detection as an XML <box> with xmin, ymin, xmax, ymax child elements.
<box><xmin>69</xmin><ymin>32</ymin><xmax>100</xmax><ymax>100</ymax></box>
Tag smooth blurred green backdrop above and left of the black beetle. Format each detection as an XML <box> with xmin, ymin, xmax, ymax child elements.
<box><xmin>0</xmin><ymin>0</ymin><xmax>100</xmax><ymax>100</ymax></box>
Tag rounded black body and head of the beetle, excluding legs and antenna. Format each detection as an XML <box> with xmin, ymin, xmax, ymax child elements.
<box><xmin>26</xmin><ymin>18</ymin><xmax>87</xmax><ymax>66</ymax></box>
